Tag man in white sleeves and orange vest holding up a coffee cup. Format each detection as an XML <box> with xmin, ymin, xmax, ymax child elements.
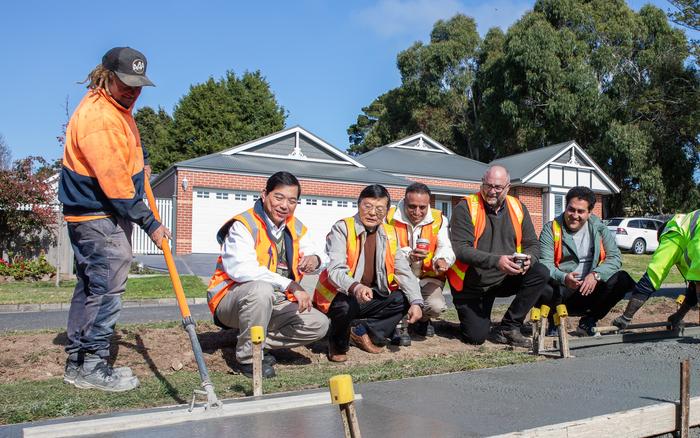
<box><xmin>387</xmin><ymin>182</ymin><xmax>455</xmax><ymax>336</ymax></box>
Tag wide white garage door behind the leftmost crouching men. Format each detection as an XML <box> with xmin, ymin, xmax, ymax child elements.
<box><xmin>192</xmin><ymin>188</ymin><xmax>357</xmax><ymax>254</ymax></box>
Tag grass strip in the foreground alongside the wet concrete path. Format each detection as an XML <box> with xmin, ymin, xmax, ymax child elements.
<box><xmin>0</xmin><ymin>350</ymin><xmax>537</xmax><ymax>424</ymax></box>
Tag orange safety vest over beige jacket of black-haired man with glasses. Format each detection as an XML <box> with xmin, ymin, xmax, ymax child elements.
<box><xmin>313</xmin><ymin>217</ymin><xmax>399</xmax><ymax>313</ymax></box>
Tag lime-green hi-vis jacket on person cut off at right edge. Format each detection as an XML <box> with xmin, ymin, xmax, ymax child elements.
<box><xmin>646</xmin><ymin>210</ymin><xmax>700</xmax><ymax>290</ymax></box>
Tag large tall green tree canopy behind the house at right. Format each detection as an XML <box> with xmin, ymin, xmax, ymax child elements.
<box><xmin>348</xmin><ymin>0</ymin><xmax>700</xmax><ymax>213</ymax></box>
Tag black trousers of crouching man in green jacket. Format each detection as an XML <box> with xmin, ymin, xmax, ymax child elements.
<box><xmin>550</xmin><ymin>271</ymin><xmax>634</xmax><ymax>322</ymax></box>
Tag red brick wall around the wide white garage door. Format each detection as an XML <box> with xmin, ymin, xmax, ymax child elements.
<box><xmin>176</xmin><ymin>170</ymin><xmax>405</xmax><ymax>255</ymax></box>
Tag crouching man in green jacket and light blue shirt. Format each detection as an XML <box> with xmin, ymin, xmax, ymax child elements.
<box><xmin>540</xmin><ymin>187</ymin><xmax>634</xmax><ymax>336</ymax></box>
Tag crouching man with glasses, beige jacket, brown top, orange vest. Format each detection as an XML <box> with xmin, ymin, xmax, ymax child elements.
<box><xmin>314</xmin><ymin>184</ymin><xmax>423</xmax><ymax>362</ymax></box>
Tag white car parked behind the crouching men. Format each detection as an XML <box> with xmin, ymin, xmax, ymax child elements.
<box><xmin>605</xmin><ymin>217</ymin><xmax>663</xmax><ymax>254</ymax></box>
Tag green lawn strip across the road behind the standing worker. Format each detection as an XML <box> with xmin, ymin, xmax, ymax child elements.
<box><xmin>0</xmin><ymin>275</ymin><xmax>207</xmax><ymax>304</ymax></box>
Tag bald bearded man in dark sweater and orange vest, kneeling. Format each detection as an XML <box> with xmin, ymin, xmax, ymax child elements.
<box><xmin>447</xmin><ymin>165</ymin><xmax>551</xmax><ymax>348</ymax></box>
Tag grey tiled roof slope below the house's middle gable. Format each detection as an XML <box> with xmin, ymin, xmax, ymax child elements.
<box><xmin>357</xmin><ymin>146</ymin><xmax>488</xmax><ymax>181</ymax></box>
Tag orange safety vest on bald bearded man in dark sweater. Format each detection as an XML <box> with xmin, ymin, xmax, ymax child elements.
<box><xmin>447</xmin><ymin>193</ymin><xmax>525</xmax><ymax>293</ymax></box>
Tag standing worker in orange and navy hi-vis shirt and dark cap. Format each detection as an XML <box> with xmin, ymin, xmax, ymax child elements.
<box><xmin>58</xmin><ymin>47</ymin><xmax>170</xmax><ymax>392</ymax></box>
